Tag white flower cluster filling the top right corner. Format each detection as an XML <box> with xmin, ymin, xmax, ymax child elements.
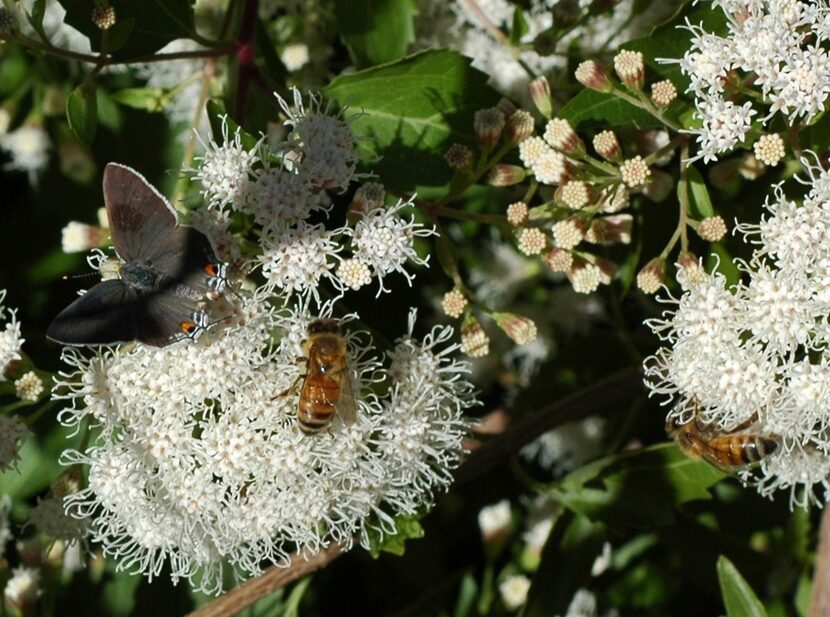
<box><xmin>665</xmin><ymin>0</ymin><xmax>830</xmax><ymax>162</ymax></box>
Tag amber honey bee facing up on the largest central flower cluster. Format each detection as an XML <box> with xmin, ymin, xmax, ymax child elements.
<box><xmin>286</xmin><ymin>319</ymin><xmax>356</xmax><ymax>435</ymax></box>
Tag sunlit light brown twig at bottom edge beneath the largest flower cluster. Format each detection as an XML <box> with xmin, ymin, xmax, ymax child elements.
<box><xmin>188</xmin><ymin>543</ymin><xmax>343</xmax><ymax>617</ymax></box>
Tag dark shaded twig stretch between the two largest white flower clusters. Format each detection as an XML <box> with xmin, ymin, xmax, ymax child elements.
<box><xmin>455</xmin><ymin>367</ymin><xmax>643</xmax><ymax>484</ymax></box>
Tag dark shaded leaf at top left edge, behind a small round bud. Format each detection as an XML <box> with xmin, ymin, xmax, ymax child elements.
<box><xmin>58</xmin><ymin>0</ymin><xmax>195</xmax><ymax>60</ymax></box>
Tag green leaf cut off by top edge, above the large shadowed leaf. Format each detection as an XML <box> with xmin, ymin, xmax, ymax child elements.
<box><xmin>334</xmin><ymin>0</ymin><xmax>418</xmax><ymax>68</ymax></box>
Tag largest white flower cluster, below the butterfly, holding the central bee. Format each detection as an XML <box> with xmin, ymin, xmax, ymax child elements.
<box><xmin>55</xmin><ymin>298</ymin><xmax>473</xmax><ymax>593</ymax></box>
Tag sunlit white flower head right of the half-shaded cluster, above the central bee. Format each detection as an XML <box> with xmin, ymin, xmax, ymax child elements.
<box><xmin>349</xmin><ymin>200</ymin><xmax>436</xmax><ymax>294</ymax></box>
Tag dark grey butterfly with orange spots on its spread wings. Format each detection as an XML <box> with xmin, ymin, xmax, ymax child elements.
<box><xmin>46</xmin><ymin>163</ymin><xmax>227</xmax><ymax>347</ymax></box>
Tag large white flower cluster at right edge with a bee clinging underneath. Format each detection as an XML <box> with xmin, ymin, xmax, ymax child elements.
<box><xmin>645</xmin><ymin>160</ymin><xmax>830</xmax><ymax>504</ymax></box>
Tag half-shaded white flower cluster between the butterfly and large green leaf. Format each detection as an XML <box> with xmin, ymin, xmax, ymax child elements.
<box><xmin>191</xmin><ymin>90</ymin><xmax>434</xmax><ymax>301</ymax></box>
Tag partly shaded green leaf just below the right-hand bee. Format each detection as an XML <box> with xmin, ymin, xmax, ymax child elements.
<box><xmin>551</xmin><ymin>443</ymin><xmax>724</xmax><ymax>528</ymax></box>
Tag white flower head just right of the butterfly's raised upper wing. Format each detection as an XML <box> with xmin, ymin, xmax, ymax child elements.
<box><xmin>192</xmin><ymin>116</ymin><xmax>264</xmax><ymax>210</ymax></box>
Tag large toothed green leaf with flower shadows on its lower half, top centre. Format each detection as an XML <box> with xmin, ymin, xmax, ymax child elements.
<box><xmin>323</xmin><ymin>50</ymin><xmax>499</xmax><ymax>198</ymax></box>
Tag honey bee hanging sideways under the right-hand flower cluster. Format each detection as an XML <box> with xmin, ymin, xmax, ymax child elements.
<box><xmin>666</xmin><ymin>404</ymin><xmax>781</xmax><ymax>474</ymax></box>
